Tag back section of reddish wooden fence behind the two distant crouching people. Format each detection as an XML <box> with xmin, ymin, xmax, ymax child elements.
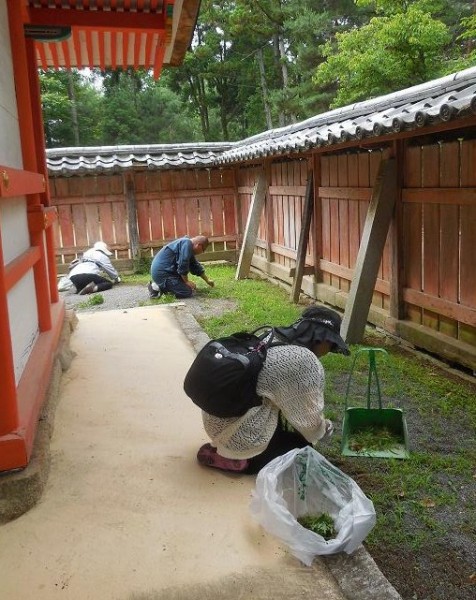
<box><xmin>50</xmin><ymin>164</ymin><xmax>242</xmax><ymax>272</ymax></box>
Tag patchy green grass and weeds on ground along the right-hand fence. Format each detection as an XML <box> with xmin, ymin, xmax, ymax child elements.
<box><xmin>126</xmin><ymin>266</ymin><xmax>476</xmax><ymax>600</ymax></box>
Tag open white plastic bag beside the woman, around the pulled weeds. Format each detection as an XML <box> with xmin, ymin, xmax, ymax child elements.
<box><xmin>250</xmin><ymin>446</ymin><xmax>376</xmax><ymax>566</ymax></box>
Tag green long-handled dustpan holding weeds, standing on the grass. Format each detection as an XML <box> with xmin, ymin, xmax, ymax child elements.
<box><xmin>341</xmin><ymin>348</ymin><xmax>410</xmax><ymax>458</ymax></box>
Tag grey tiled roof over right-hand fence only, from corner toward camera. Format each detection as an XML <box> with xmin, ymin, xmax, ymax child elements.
<box><xmin>219</xmin><ymin>68</ymin><xmax>476</xmax><ymax>162</ymax></box>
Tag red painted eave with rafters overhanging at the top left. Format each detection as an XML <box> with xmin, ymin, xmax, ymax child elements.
<box><xmin>19</xmin><ymin>0</ymin><xmax>200</xmax><ymax>77</ymax></box>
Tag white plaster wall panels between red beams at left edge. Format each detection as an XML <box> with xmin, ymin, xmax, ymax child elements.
<box><xmin>0</xmin><ymin>0</ymin><xmax>38</xmax><ymax>383</ymax></box>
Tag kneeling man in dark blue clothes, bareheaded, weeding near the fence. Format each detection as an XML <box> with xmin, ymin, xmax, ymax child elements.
<box><xmin>147</xmin><ymin>235</ymin><xmax>215</xmax><ymax>298</ymax></box>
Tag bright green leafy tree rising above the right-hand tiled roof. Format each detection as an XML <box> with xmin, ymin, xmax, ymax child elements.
<box><xmin>314</xmin><ymin>0</ymin><xmax>451</xmax><ymax>107</ymax></box>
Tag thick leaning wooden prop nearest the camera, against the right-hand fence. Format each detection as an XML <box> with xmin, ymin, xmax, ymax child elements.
<box><xmin>341</xmin><ymin>158</ymin><xmax>397</xmax><ymax>344</ymax></box>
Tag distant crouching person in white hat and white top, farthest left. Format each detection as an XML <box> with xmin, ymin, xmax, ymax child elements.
<box><xmin>68</xmin><ymin>242</ymin><xmax>121</xmax><ymax>296</ymax></box>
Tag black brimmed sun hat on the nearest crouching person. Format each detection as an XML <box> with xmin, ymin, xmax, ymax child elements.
<box><xmin>276</xmin><ymin>306</ymin><xmax>350</xmax><ymax>356</ymax></box>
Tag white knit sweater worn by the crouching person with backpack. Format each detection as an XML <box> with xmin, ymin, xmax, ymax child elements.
<box><xmin>202</xmin><ymin>345</ymin><xmax>326</xmax><ymax>458</ymax></box>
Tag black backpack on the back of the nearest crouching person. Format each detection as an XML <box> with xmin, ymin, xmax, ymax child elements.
<box><xmin>183</xmin><ymin>327</ymin><xmax>274</xmax><ymax>418</ymax></box>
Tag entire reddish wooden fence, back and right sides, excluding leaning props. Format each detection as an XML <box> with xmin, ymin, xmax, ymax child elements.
<box><xmin>51</xmin><ymin>139</ymin><xmax>476</xmax><ymax>370</ymax></box>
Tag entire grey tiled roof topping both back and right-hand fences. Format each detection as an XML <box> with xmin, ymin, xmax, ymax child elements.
<box><xmin>46</xmin><ymin>67</ymin><xmax>476</xmax><ymax>176</ymax></box>
